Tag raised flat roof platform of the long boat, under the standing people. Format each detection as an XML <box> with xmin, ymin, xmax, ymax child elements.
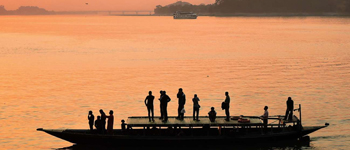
<box><xmin>127</xmin><ymin>116</ymin><xmax>262</xmax><ymax>126</ymax></box>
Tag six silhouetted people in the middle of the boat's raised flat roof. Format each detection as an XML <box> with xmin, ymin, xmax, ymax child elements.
<box><xmin>144</xmin><ymin>88</ymin><xmax>230</xmax><ymax>122</ymax></box>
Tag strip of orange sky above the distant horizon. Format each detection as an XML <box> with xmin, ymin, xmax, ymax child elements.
<box><xmin>0</xmin><ymin>0</ymin><xmax>215</xmax><ymax>11</ymax></box>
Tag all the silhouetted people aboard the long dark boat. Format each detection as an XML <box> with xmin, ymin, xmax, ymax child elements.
<box><xmin>88</xmin><ymin>88</ymin><xmax>294</xmax><ymax>134</ymax></box>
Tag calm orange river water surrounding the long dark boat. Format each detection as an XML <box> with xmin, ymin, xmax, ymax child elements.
<box><xmin>0</xmin><ymin>16</ymin><xmax>350</xmax><ymax>149</ymax></box>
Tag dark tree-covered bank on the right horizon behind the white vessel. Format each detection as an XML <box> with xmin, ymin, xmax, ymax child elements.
<box><xmin>154</xmin><ymin>0</ymin><xmax>350</xmax><ymax>15</ymax></box>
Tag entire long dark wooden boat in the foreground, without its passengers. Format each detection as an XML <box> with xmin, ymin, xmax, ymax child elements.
<box><xmin>37</xmin><ymin>105</ymin><xmax>328</xmax><ymax>146</ymax></box>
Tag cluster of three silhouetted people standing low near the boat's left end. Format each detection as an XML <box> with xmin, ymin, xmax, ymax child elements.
<box><xmin>88</xmin><ymin>109</ymin><xmax>114</xmax><ymax>134</ymax></box>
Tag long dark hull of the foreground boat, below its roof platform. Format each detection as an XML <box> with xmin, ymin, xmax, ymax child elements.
<box><xmin>38</xmin><ymin>126</ymin><xmax>326</xmax><ymax>146</ymax></box>
